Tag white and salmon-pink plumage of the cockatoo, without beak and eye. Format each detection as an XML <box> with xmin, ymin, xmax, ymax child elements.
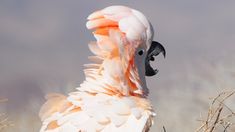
<box><xmin>39</xmin><ymin>6</ymin><xmax>162</xmax><ymax>132</ymax></box>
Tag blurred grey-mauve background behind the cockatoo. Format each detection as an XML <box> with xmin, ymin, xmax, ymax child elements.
<box><xmin>0</xmin><ymin>0</ymin><xmax>235</xmax><ymax>132</ymax></box>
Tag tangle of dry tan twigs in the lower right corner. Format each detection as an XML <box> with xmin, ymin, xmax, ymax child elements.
<box><xmin>196</xmin><ymin>91</ymin><xmax>235</xmax><ymax>132</ymax></box>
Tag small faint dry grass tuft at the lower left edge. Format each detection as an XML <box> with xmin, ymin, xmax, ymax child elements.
<box><xmin>0</xmin><ymin>99</ymin><xmax>12</xmax><ymax>131</ymax></box>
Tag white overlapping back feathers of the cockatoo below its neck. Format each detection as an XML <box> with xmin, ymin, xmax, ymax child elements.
<box><xmin>41</xmin><ymin>92</ymin><xmax>152</xmax><ymax>132</ymax></box>
